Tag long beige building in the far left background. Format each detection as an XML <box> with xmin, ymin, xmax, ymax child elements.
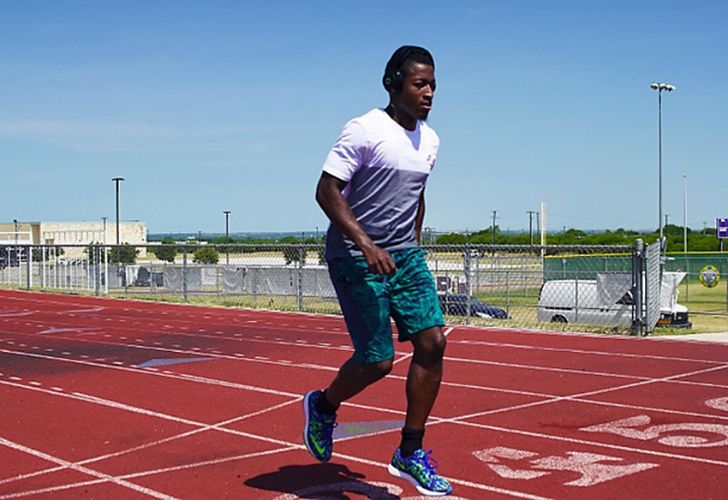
<box><xmin>0</xmin><ymin>221</ymin><xmax>147</xmax><ymax>256</ymax></box>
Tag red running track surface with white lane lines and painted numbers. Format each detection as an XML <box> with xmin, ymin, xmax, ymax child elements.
<box><xmin>0</xmin><ymin>291</ymin><xmax>728</xmax><ymax>499</ymax></box>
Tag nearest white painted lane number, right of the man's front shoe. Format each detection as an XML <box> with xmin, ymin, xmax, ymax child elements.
<box><xmin>473</xmin><ymin>446</ymin><xmax>657</xmax><ymax>487</ymax></box>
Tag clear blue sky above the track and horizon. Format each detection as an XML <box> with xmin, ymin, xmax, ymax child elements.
<box><xmin>0</xmin><ymin>0</ymin><xmax>728</xmax><ymax>233</ymax></box>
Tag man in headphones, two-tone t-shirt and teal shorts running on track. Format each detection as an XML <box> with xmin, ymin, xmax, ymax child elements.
<box><xmin>303</xmin><ymin>46</ymin><xmax>452</xmax><ymax>496</ymax></box>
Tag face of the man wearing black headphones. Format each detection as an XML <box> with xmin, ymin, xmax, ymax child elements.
<box><xmin>392</xmin><ymin>62</ymin><xmax>435</xmax><ymax>126</ymax></box>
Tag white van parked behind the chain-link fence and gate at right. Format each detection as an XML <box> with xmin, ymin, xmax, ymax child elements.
<box><xmin>537</xmin><ymin>272</ymin><xmax>692</xmax><ymax>328</ymax></box>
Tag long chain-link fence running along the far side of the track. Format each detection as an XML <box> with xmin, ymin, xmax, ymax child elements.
<box><xmin>0</xmin><ymin>244</ymin><xmax>728</xmax><ymax>331</ymax></box>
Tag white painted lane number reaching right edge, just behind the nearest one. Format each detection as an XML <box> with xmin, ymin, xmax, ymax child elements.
<box><xmin>579</xmin><ymin>415</ymin><xmax>728</xmax><ymax>448</ymax></box>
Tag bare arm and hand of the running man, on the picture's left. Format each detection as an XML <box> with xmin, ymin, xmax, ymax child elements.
<box><xmin>316</xmin><ymin>172</ymin><xmax>396</xmax><ymax>274</ymax></box>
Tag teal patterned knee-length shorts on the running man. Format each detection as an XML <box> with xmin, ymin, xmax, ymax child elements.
<box><xmin>328</xmin><ymin>248</ymin><xmax>445</xmax><ymax>363</ymax></box>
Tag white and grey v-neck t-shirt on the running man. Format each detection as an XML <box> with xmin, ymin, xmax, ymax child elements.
<box><xmin>323</xmin><ymin>109</ymin><xmax>440</xmax><ymax>259</ymax></box>
